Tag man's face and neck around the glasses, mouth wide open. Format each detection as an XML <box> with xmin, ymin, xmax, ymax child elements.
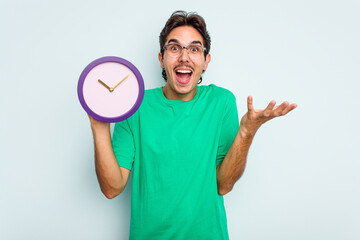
<box><xmin>159</xmin><ymin>26</ymin><xmax>211</xmax><ymax>101</ymax></box>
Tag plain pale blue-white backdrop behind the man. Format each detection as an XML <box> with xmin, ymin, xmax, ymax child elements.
<box><xmin>0</xmin><ymin>0</ymin><xmax>360</xmax><ymax>240</ymax></box>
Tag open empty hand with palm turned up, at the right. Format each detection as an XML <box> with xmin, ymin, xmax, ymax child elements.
<box><xmin>240</xmin><ymin>96</ymin><xmax>297</xmax><ymax>136</ymax></box>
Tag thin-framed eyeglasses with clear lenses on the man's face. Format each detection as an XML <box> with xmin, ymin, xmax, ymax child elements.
<box><xmin>164</xmin><ymin>43</ymin><xmax>206</xmax><ymax>59</ymax></box>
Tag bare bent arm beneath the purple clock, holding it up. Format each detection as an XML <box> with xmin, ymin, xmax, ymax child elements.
<box><xmin>89</xmin><ymin>116</ymin><xmax>130</xmax><ymax>199</ymax></box>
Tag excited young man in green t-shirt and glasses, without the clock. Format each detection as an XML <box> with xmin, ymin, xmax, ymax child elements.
<box><xmin>90</xmin><ymin>11</ymin><xmax>296</xmax><ymax>239</ymax></box>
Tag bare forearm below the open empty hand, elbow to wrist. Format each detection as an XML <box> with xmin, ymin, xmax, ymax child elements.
<box><xmin>217</xmin><ymin>126</ymin><xmax>256</xmax><ymax>195</ymax></box>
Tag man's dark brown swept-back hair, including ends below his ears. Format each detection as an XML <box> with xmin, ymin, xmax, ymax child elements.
<box><xmin>159</xmin><ymin>11</ymin><xmax>211</xmax><ymax>83</ymax></box>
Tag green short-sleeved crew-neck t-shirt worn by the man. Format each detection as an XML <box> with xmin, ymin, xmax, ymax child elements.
<box><xmin>113</xmin><ymin>85</ymin><xmax>239</xmax><ymax>240</ymax></box>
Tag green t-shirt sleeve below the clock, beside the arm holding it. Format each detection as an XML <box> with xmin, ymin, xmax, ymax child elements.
<box><xmin>112</xmin><ymin>120</ymin><xmax>135</xmax><ymax>170</ymax></box>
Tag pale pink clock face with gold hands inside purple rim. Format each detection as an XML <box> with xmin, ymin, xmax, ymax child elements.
<box><xmin>83</xmin><ymin>62</ymin><xmax>139</xmax><ymax>118</ymax></box>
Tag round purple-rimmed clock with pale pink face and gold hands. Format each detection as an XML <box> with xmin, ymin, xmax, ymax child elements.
<box><xmin>78</xmin><ymin>57</ymin><xmax>144</xmax><ymax>122</ymax></box>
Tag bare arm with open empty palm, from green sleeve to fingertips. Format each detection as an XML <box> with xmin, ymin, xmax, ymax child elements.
<box><xmin>216</xmin><ymin>96</ymin><xmax>297</xmax><ymax>195</ymax></box>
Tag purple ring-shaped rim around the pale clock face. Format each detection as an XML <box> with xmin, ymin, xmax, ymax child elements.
<box><xmin>77</xmin><ymin>56</ymin><xmax>145</xmax><ymax>123</ymax></box>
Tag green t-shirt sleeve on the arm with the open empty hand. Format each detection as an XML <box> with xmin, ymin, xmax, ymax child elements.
<box><xmin>216</xmin><ymin>93</ymin><xmax>239</xmax><ymax>166</ymax></box>
